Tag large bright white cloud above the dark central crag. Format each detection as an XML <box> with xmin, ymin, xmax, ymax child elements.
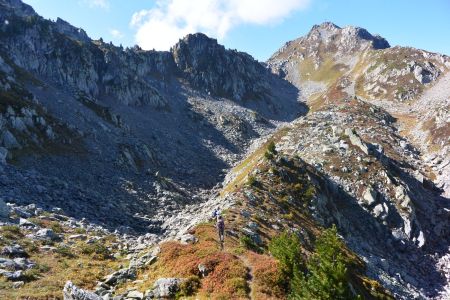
<box><xmin>130</xmin><ymin>0</ymin><xmax>310</xmax><ymax>50</ymax></box>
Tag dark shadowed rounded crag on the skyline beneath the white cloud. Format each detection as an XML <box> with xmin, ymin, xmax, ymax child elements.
<box><xmin>172</xmin><ymin>33</ymin><xmax>270</xmax><ymax>101</ymax></box>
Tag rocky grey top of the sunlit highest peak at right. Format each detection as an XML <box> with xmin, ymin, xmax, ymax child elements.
<box><xmin>305</xmin><ymin>22</ymin><xmax>390</xmax><ymax>50</ymax></box>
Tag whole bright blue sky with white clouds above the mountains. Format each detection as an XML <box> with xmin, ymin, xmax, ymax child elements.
<box><xmin>24</xmin><ymin>0</ymin><xmax>450</xmax><ymax>61</ymax></box>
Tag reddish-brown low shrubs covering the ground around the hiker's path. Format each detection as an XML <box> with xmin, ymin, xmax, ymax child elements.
<box><xmin>119</xmin><ymin>224</ymin><xmax>249</xmax><ymax>299</ymax></box>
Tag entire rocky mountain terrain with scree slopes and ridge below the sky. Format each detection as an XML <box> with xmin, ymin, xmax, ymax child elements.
<box><xmin>0</xmin><ymin>0</ymin><xmax>450</xmax><ymax>300</ymax></box>
